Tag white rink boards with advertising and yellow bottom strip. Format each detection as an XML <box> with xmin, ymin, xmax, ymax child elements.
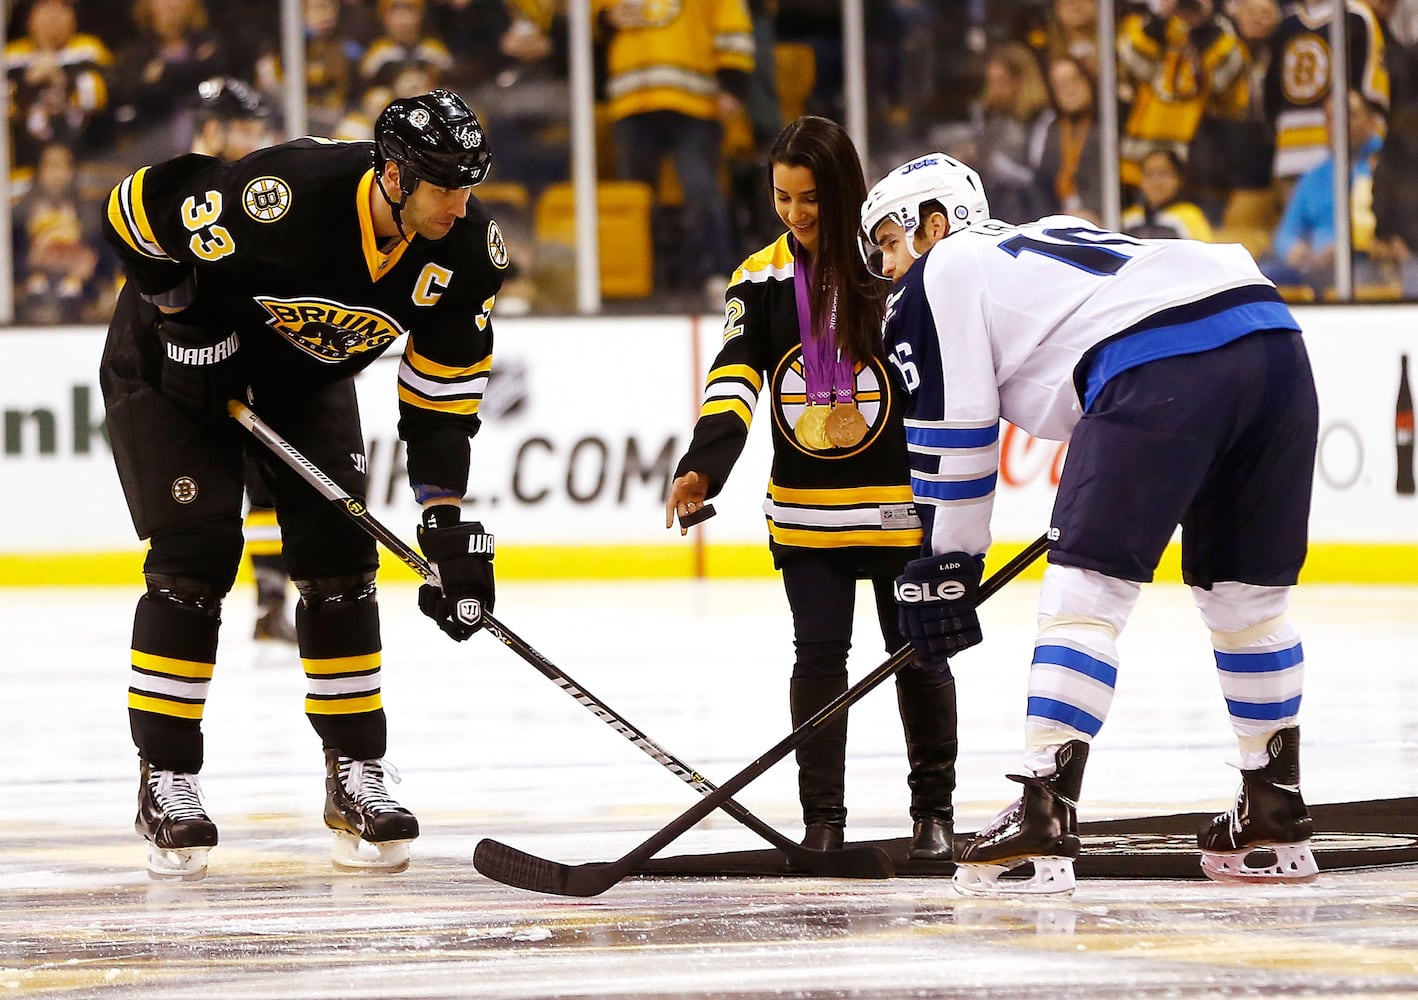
<box><xmin>0</xmin><ymin>305</ymin><xmax>1418</xmax><ymax>586</ymax></box>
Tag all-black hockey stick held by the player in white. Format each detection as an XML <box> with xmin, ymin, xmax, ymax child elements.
<box><xmin>472</xmin><ymin>535</ymin><xmax>1049</xmax><ymax>896</ymax></box>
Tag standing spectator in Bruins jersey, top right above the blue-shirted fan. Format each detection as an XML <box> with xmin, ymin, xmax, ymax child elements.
<box><xmin>1265</xmin><ymin>0</ymin><xmax>1390</xmax><ymax>199</ymax></box>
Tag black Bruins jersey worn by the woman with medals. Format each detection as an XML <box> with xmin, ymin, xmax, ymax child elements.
<box><xmin>675</xmin><ymin>233</ymin><xmax>922</xmax><ymax>567</ymax></box>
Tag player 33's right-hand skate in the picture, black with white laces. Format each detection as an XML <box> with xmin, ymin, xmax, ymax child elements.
<box><xmin>325</xmin><ymin>749</ymin><xmax>418</xmax><ymax>871</ymax></box>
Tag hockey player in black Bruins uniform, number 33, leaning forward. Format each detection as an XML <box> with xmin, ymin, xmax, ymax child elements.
<box><xmin>101</xmin><ymin>91</ymin><xmax>508</xmax><ymax>878</ymax></box>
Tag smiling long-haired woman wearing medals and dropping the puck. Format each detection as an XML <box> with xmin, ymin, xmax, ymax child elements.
<box><xmin>665</xmin><ymin>116</ymin><xmax>956</xmax><ymax>861</ymax></box>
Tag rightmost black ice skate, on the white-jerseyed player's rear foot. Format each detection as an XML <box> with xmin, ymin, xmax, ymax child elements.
<box><xmin>1197</xmin><ymin>726</ymin><xmax>1320</xmax><ymax>882</ymax></box>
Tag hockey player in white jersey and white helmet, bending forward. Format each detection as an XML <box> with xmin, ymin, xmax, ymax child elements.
<box><xmin>859</xmin><ymin>153</ymin><xmax>1317</xmax><ymax>895</ymax></box>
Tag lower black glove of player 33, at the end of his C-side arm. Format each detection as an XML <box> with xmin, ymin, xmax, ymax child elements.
<box><xmin>418</xmin><ymin>504</ymin><xmax>495</xmax><ymax>643</ymax></box>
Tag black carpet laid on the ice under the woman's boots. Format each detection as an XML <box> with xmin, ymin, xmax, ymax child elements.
<box><xmin>638</xmin><ymin>797</ymin><xmax>1418</xmax><ymax>881</ymax></box>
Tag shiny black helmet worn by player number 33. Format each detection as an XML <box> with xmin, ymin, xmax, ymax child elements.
<box><xmin>374</xmin><ymin>89</ymin><xmax>492</xmax><ymax>199</ymax></box>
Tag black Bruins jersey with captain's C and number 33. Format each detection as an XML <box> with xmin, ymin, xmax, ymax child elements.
<box><xmin>105</xmin><ymin>139</ymin><xmax>508</xmax><ymax>491</ymax></box>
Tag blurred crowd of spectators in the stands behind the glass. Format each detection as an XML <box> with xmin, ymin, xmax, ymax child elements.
<box><xmin>4</xmin><ymin>0</ymin><xmax>1418</xmax><ymax>323</ymax></box>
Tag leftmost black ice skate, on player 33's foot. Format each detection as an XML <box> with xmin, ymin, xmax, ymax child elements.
<box><xmin>133</xmin><ymin>760</ymin><xmax>217</xmax><ymax>881</ymax></box>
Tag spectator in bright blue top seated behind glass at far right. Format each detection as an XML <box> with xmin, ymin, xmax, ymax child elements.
<box><xmin>1261</xmin><ymin>91</ymin><xmax>1384</xmax><ymax>295</ymax></box>
